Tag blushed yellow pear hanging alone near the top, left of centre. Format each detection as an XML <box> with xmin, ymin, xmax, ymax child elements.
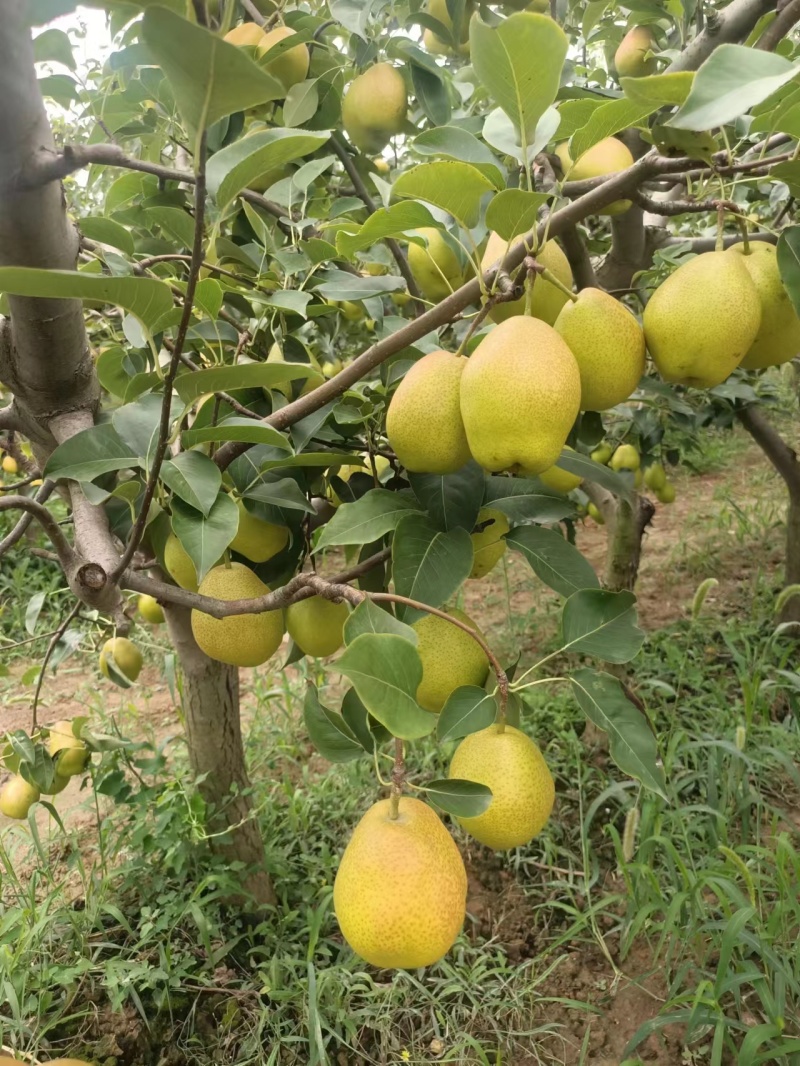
<box><xmin>341</xmin><ymin>63</ymin><xmax>409</xmax><ymax>155</ymax></box>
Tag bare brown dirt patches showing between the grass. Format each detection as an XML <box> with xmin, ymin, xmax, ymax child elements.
<box><xmin>0</xmin><ymin>453</ymin><xmax>783</xmax><ymax>1066</ymax></box>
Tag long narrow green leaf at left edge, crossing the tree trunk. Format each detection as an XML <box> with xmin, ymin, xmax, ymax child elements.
<box><xmin>0</xmin><ymin>267</ymin><xmax>172</xmax><ymax>329</ymax></box>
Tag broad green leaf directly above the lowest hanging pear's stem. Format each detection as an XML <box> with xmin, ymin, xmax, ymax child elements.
<box><xmin>336</xmin><ymin>633</ymin><xmax>436</xmax><ymax>740</ymax></box>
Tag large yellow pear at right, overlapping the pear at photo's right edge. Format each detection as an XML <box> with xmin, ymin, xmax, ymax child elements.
<box><xmin>643</xmin><ymin>252</ymin><xmax>762</xmax><ymax>389</ymax></box>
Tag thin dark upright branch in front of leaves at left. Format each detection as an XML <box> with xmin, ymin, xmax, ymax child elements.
<box><xmin>111</xmin><ymin>133</ymin><xmax>206</xmax><ymax>581</ymax></box>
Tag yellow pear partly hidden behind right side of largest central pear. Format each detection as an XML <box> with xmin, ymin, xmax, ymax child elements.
<box><xmin>554</xmin><ymin>282</ymin><xmax>644</xmax><ymax>410</ymax></box>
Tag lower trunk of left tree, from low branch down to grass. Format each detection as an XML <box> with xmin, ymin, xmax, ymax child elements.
<box><xmin>164</xmin><ymin>607</ymin><xmax>276</xmax><ymax>904</ymax></box>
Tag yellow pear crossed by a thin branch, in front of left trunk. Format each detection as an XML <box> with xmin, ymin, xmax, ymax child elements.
<box><xmin>192</xmin><ymin>563</ymin><xmax>284</xmax><ymax>666</ymax></box>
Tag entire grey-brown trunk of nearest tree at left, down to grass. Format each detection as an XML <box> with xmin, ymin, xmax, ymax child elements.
<box><xmin>0</xmin><ymin>6</ymin><xmax>275</xmax><ymax>904</ymax></box>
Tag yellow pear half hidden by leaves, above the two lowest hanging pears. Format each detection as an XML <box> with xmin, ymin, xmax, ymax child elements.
<box><xmin>414</xmin><ymin>610</ymin><xmax>489</xmax><ymax>714</ymax></box>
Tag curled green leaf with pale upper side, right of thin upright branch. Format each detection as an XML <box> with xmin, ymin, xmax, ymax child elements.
<box><xmin>208</xmin><ymin>127</ymin><xmax>331</xmax><ymax>209</ymax></box>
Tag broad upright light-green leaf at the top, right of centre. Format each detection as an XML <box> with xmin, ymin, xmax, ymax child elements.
<box><xmin>469</xmin><ymin>12</ymin><xmax>567</xmax><ymax>143</ymax></box>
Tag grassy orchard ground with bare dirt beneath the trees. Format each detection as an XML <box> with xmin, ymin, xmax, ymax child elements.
<box><xmin>0</xmin><ymin>426</ymin><xmax>800</xmax><ymax>1066</ymax></box>
